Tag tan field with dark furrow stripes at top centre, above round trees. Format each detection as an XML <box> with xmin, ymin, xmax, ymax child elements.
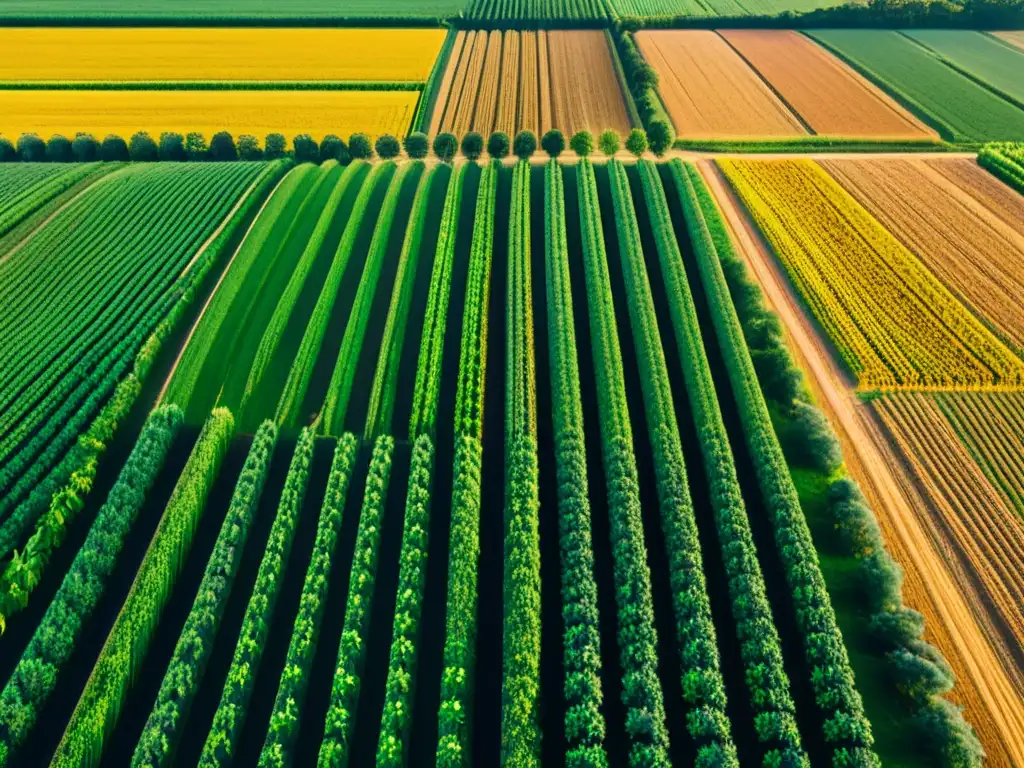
<box><xmin>431</xmin><ymin>31</ymin><xmax>632</xmax><ymax>138</ymax></box>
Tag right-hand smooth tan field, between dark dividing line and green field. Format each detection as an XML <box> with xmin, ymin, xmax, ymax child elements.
<box><xmin>719</xmin><ymin>30</ymin><xmax>938</xmax><ymax>139</ymax></box>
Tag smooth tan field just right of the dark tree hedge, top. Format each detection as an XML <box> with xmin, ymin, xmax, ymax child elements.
<box><xmin>636</xmin><ymin>30</ymin><xmax>807</xmax><ymax>139</ymax></box>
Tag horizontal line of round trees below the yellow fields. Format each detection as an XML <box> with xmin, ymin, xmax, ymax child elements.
<box><xmin>0</xmin><ymin>128</ymin><xmax>672</xmax><ymax>163</ymax></box>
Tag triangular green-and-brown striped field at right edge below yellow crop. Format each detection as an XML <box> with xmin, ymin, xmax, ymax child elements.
<box><xmin>935</xmin><ymin>392</ymin><xmax>1024</xmax><ymax>516</ymax></box>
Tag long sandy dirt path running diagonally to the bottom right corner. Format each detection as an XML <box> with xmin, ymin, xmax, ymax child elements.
<box><xmin>699</xmin><ymin>161</ymin><xmax>1024</xmax><ymax>766</ymax></box>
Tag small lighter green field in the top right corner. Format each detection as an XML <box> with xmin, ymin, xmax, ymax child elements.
<box><xmin>904</xmin><ymin>30</ymin><xmax>1024</xmax><ymax>104</ymax></box>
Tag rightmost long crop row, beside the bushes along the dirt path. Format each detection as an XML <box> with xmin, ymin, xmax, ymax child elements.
<box><xmin>671</xmin><ymin>161</ymin><xmax>881</xmax><ymax>766</ymax></box>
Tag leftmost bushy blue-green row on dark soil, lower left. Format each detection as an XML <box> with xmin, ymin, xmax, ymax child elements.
<box><xmin>0</xmin><ymin>406</ymin><xmax>182</xmax><ymax>765</ymax></box>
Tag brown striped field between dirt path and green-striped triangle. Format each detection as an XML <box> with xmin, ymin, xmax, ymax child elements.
<box><xmin>871</xmin><ymin>393</ymin><xmax>1024</xmax><ymax>678</ymax></box>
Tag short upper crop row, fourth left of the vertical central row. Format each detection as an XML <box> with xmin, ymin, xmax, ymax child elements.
<box><xmin>321</xmin><ymin>161</ymin><xmax>413</xmax><ymax>434</ymax></box>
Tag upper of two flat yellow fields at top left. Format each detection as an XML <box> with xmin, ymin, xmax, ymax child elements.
<box><xmin>0</xmin><ymin>28</ymin><xmax>445</xmax><ymax>83</ymax></box>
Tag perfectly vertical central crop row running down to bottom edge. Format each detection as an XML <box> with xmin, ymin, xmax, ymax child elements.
<box><xmin>501</xmin><ymin>161</ymin><xmax>541</xmax><ymax>767</ymax></box>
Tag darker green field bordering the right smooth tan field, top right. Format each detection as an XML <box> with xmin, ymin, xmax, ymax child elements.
<box><xmin>810</xmin><ymin>30</ymin><xmax>1024</xmax><ymax>141</ymax></box>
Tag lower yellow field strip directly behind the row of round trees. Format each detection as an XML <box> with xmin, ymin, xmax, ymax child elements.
<box><xmin>0</xmin><ymin>90</ymin><xmax>420</xmax><ymax>140</ymax></box>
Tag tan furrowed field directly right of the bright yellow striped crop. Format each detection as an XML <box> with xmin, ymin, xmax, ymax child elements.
<box><xmin>821</xmin><ymin>159</ymin><xmax>1024</xmax><ymax>358</ymax></box>
